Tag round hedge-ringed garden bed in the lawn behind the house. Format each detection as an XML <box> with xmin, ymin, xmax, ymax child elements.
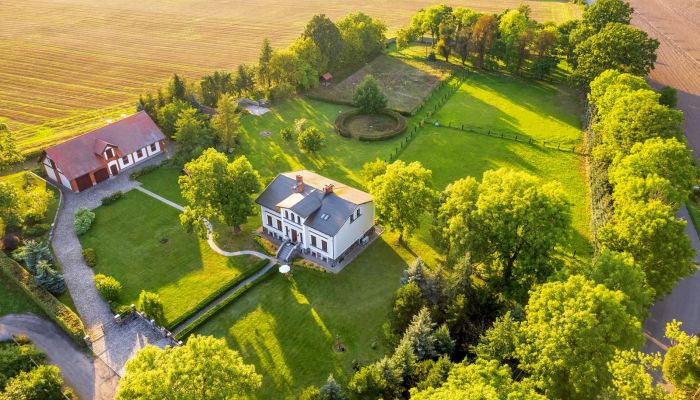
<box><xmin>335</xmin><ymin>110</ymin><xmax>406</xmax><ymax>141</ymax></box>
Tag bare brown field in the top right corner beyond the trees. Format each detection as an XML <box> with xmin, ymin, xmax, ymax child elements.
<box><xmin>630</xmin><ymin>0</ymin><xmax>700</xmax><ymax>160</ymax></box>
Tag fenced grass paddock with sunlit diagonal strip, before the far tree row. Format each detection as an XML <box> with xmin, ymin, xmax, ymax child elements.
<box><xmin>431</xmin><ymin>72</ymin><xmax>582</xmax><ymax>145</ymax></box>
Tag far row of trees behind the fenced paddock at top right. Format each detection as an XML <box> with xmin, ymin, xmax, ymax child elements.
<box><xmin>396</xmin><ymin>0</ymin><xmax>659</xmax><ymax>87</ymax></box>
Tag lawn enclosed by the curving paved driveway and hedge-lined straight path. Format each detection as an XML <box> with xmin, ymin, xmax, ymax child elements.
<box><xmin>80</xmin><ymin>190</ymin><xmax>258</xmax><ymax>321</ymax></box>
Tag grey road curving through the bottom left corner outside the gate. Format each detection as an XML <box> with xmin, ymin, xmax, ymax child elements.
<box><xmin>0</xmin><ymin>314</ymin><xmax>119</xmax><ymax>400</ymax></box>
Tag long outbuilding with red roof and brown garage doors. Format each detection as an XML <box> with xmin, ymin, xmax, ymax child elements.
<box><xmin>40</xmin><ymin>111</ymin><xmax>165</xmax><ymax>192</ymax></box>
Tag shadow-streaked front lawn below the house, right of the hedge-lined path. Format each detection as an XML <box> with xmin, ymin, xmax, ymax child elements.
<box><xmin>196</xmin><ymin>235</ymin><xmax>412</xmax><ymax>399</ymax></box>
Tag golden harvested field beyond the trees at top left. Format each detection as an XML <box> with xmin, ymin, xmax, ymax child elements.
<box><xmin>0</xmin><ymin>0</ymin><xmax>580</xmax><ymax>152</ymax></box>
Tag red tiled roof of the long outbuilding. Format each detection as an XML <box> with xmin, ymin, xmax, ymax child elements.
<box><xmin>44</xmin><ymin>111</ymin><xmax>165</xmax><ymax>180</ymax></box>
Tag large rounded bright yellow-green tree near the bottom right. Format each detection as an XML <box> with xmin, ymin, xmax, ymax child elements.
<box><xmin>515</xmin><ymin>275</ymin><xmax>643</xmax><ymax>399</ymax></box>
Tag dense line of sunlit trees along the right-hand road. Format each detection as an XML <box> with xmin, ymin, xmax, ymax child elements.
<box><xmin>588</xmin><ymin>70</ymin><xmax>697</xmax><ymax>297</ymax></box>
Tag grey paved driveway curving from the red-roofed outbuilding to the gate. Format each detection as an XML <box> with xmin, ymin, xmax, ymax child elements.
<box><xmin>51</xmin><ymin>154</ymin><xmax>169</xmax><ymax>375</ymax></box>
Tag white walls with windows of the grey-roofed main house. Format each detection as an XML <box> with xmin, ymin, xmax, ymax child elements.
<box><xmin>260</xmin><ymin>202</ymin><xmax>374</xmax><ymax>261</ymax></box>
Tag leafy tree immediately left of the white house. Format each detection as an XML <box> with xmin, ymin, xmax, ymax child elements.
<box><xmin>179</xmin><ymin>149</ymin><xmax>260</xmax><ymax>236</ymax></box>
